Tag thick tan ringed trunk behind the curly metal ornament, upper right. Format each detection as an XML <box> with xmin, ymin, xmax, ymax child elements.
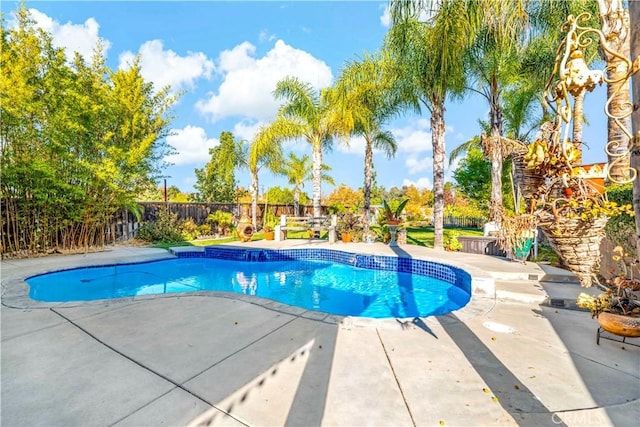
<box><xmin>598</xmin><ymin>0</ymin><xmax>631</xmax><ymax>181</ymax></box>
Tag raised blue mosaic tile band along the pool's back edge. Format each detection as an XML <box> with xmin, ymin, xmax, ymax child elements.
<box><xmin>174</xmin><ymin>246</ymin><xmax>471</xmax><ymax>295</ymax></box>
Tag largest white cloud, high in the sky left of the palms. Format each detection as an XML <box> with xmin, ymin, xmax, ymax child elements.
<box><xmin>196</xmin><ymin>40</ymin><xmax>333</xmax><ymax>121</ymax></box>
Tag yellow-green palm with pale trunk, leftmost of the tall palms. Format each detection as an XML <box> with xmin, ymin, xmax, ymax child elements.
<box><xmin>261</xmin><ymin>77</ymin><xmax>349</xmax><ymax>217</ymax></box>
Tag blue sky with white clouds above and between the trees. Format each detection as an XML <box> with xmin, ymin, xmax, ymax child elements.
<box><xmin>10</xmin><ymin>1</ymin><xmax>607</xmax><ymax>195</ymax></box>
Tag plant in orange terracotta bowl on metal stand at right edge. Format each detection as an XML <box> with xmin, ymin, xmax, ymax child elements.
<box><xmin>577</xmin><ymin>246</ymin><xmax>640</xmax><ymax>339</ymax></box>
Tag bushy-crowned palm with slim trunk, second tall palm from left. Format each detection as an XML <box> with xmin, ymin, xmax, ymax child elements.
<box><xmin>332</xmin><ymin>52</ymin><xmax>403</xmax><ymax>232</ymax></box>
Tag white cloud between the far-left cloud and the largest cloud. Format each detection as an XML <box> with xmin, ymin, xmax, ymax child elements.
<box><xmin>119</xmin><ymin>40</ymin><xmax>214</xmax><ymax>92</ymax></box>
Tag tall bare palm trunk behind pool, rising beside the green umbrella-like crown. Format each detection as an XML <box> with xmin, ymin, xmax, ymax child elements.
<box><xmin>431</xmin><ymin>103</ymin><xmax>446</xmax><ymax>249</ymax></box>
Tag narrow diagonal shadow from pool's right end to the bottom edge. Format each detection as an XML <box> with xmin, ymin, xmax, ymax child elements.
<box><xmin>435</xmin><ymin>313</ymin><xmax>565</xmax><ymax>426</ymax></box>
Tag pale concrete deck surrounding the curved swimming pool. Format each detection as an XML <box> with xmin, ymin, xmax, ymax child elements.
<box><xmin>0</xmin><ymin>240</ymin><xmax>640</xmax><ymax>426</ymax></box>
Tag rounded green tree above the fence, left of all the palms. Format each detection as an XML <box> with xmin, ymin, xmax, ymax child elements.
<box><xmin>195</xmin><ymin>131</ymin><xmax>246</xmax><ymax>203</ymax></box>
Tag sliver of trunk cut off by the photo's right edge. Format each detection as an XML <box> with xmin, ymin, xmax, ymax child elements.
<box><xmin>629</xmin><ymin>1</ymin><xmax>640</xmax><ymax>259</ymax></box>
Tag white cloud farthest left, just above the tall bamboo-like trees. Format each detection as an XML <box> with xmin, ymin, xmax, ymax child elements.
<box><xmin>29</xmin><ymin>9</ymin><xmax>111</xmax><ymax>63</ymax></box>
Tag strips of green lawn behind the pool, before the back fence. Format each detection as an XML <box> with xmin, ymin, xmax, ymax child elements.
<box><xmin>154</xmin><ymin>227</ymin><xmax>483</xmax><ymax>249</ymax></box>
